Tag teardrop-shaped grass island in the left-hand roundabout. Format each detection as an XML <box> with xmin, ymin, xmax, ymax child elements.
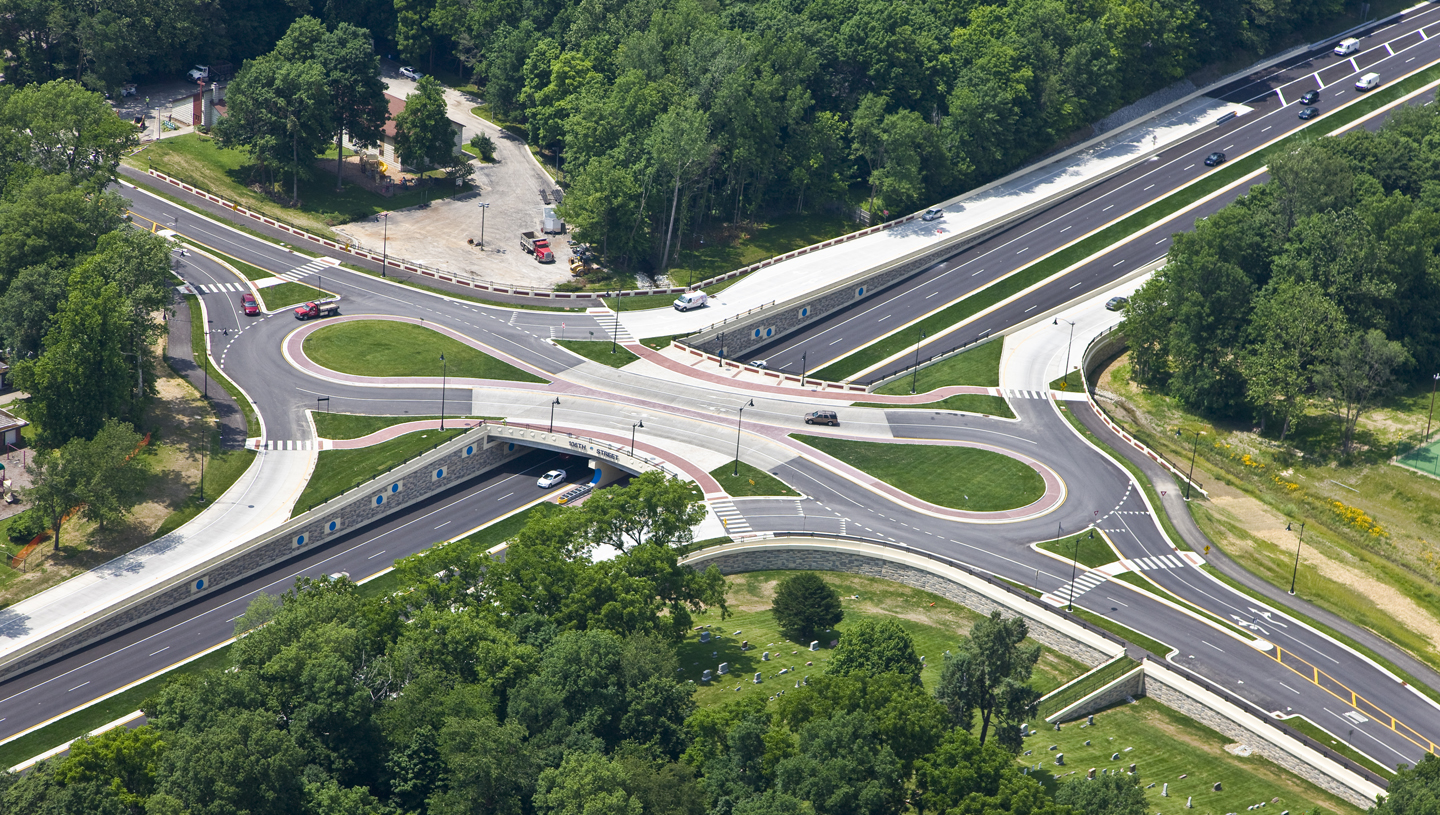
<box><xmin>305</xmin><ymin>320</ymin><xmax>546</xmax><ymax>382</ymax></box>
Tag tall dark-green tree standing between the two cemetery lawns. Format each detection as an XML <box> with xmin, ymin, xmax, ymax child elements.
<box><xmin>935</xmin><ymin>611</ymin><xmax>1040</xmax><ymax>753</ymax></box>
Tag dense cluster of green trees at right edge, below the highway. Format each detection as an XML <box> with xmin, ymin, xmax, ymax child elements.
<box><xmin>1123</xmin><ymin>105</ymin><xmax>1440</xmax><ymax>452</ymax></box>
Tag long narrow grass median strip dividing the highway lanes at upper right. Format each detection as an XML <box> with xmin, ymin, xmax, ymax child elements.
<box><xmin>815</xmin><ymin>65</ymin><xmax>1440</xmax><ymax>382</ymax></box>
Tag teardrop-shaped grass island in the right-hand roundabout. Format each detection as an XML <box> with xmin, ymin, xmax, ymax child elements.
<box><xmin>791</xmin><ymin>433</ymin><xmax>1045</xmax><ymax>513</ymax></box>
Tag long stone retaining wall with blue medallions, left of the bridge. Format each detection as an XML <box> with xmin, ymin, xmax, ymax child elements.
<box><xmin>0</xmin><ymin>426</ymin><xmax>528</xmax><ymax>688</ymax></box>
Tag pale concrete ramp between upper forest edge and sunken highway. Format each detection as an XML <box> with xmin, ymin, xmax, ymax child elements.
<box><xmin>621</xmin><ymin>96</ymin><xmax>1250</xmax><ymax>338</ymax></box>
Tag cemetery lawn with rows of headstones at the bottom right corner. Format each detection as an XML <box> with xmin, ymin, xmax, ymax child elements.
<box><xmin>1036</xmin><ymin>698</ymin><xmax>1361</xmax><ymax>815</ymax></box>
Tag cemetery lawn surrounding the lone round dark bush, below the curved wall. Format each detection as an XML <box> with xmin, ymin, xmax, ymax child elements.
<box><xmin>677</xmin><ymin>572</ymin><xmax>1086</xmax><ymax>706</ymax></box>
